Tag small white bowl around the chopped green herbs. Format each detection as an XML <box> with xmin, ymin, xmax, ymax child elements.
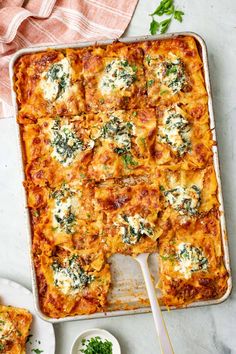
<box><xmin>71</xmin><ymin>328</ymin><xmax>121</xmax><ymax>354</ymax></box>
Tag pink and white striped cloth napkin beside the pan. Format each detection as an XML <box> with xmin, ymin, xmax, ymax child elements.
<box><xmin>0</xmin><ymin>0</ymin><xmax>138</xmax><ymax>118</ymax></box>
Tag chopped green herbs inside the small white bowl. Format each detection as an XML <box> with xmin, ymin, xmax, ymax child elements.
<box><xmin>80</xmin><ymin>336</ymin><xmax>112</xmax><ymax>354</ymax></box>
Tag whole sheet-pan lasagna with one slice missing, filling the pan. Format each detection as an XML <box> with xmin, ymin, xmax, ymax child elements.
<box><xmin>15</xmin><ymin>36</ymin><xmax>228</xmax><ymax>318</ymax></box>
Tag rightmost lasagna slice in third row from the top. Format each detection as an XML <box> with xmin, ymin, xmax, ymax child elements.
<box><xmin>157</xmin><ymin>166</ymin><xmax>219</xmax><ymax>227</ymax></box>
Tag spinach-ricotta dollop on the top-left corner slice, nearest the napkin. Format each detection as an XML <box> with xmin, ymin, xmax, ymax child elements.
<box><xmin>40</xmin><ymin>58</ymin><xmax>71</xmax><ymax>101</ymax></box>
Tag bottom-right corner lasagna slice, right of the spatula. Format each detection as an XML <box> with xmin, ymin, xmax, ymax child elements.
<box><xmin>159</xmin><ymin>212</ymin><xmax>228</xmax><ymax>307</ymax></box>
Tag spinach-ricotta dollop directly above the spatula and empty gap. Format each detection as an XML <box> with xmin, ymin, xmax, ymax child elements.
<box><xmin>116</xmin><ymin>214</ymin><xmax>154</xmax><ymax>245</ymax></box>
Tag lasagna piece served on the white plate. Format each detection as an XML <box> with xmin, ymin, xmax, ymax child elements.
<box><xmin>0</xmin><ymin>305</ymin><xmax>32</xmax><ymax>354</ymax></box>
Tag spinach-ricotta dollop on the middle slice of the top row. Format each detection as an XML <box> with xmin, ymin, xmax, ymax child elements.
<box><xmin>99</xmin><ymin>59</ymin><xmax>137</xmax><ymax>95</ymax></box>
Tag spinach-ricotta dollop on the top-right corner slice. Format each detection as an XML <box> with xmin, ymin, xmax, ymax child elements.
<box><xmin>156</xmin><ymin>54</ymin><xmax>186</xmax><ymax>94</ymax></box>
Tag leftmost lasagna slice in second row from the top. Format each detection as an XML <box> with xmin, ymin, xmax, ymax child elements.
<box><xmin>22</xmin><ymin>116</ymin><xmax>95</xmax><ymax>186</ymax></box>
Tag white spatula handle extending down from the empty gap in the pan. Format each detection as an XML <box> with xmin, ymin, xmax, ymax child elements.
<box><xmin>136</xmin><ymin>253</ymin><xmax>174</xmax><ymax>354</ymax></box>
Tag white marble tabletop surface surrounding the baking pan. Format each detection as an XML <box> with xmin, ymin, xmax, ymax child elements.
<box><xmin>0</xmin><ymin>0</ymin><xmax>236</xmax><ymax>354</ymax></box>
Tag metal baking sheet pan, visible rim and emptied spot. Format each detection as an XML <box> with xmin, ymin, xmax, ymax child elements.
<box><xmin>9</xmin><ymin>32</ymin><xmax>232</xmax><ymax>323</ymax></box>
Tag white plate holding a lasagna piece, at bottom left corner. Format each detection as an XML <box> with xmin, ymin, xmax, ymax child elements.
<box><xmin>0</xmin><ymin>278</ymin><xmax>55</xmax><ymax>354</ymax></box>
